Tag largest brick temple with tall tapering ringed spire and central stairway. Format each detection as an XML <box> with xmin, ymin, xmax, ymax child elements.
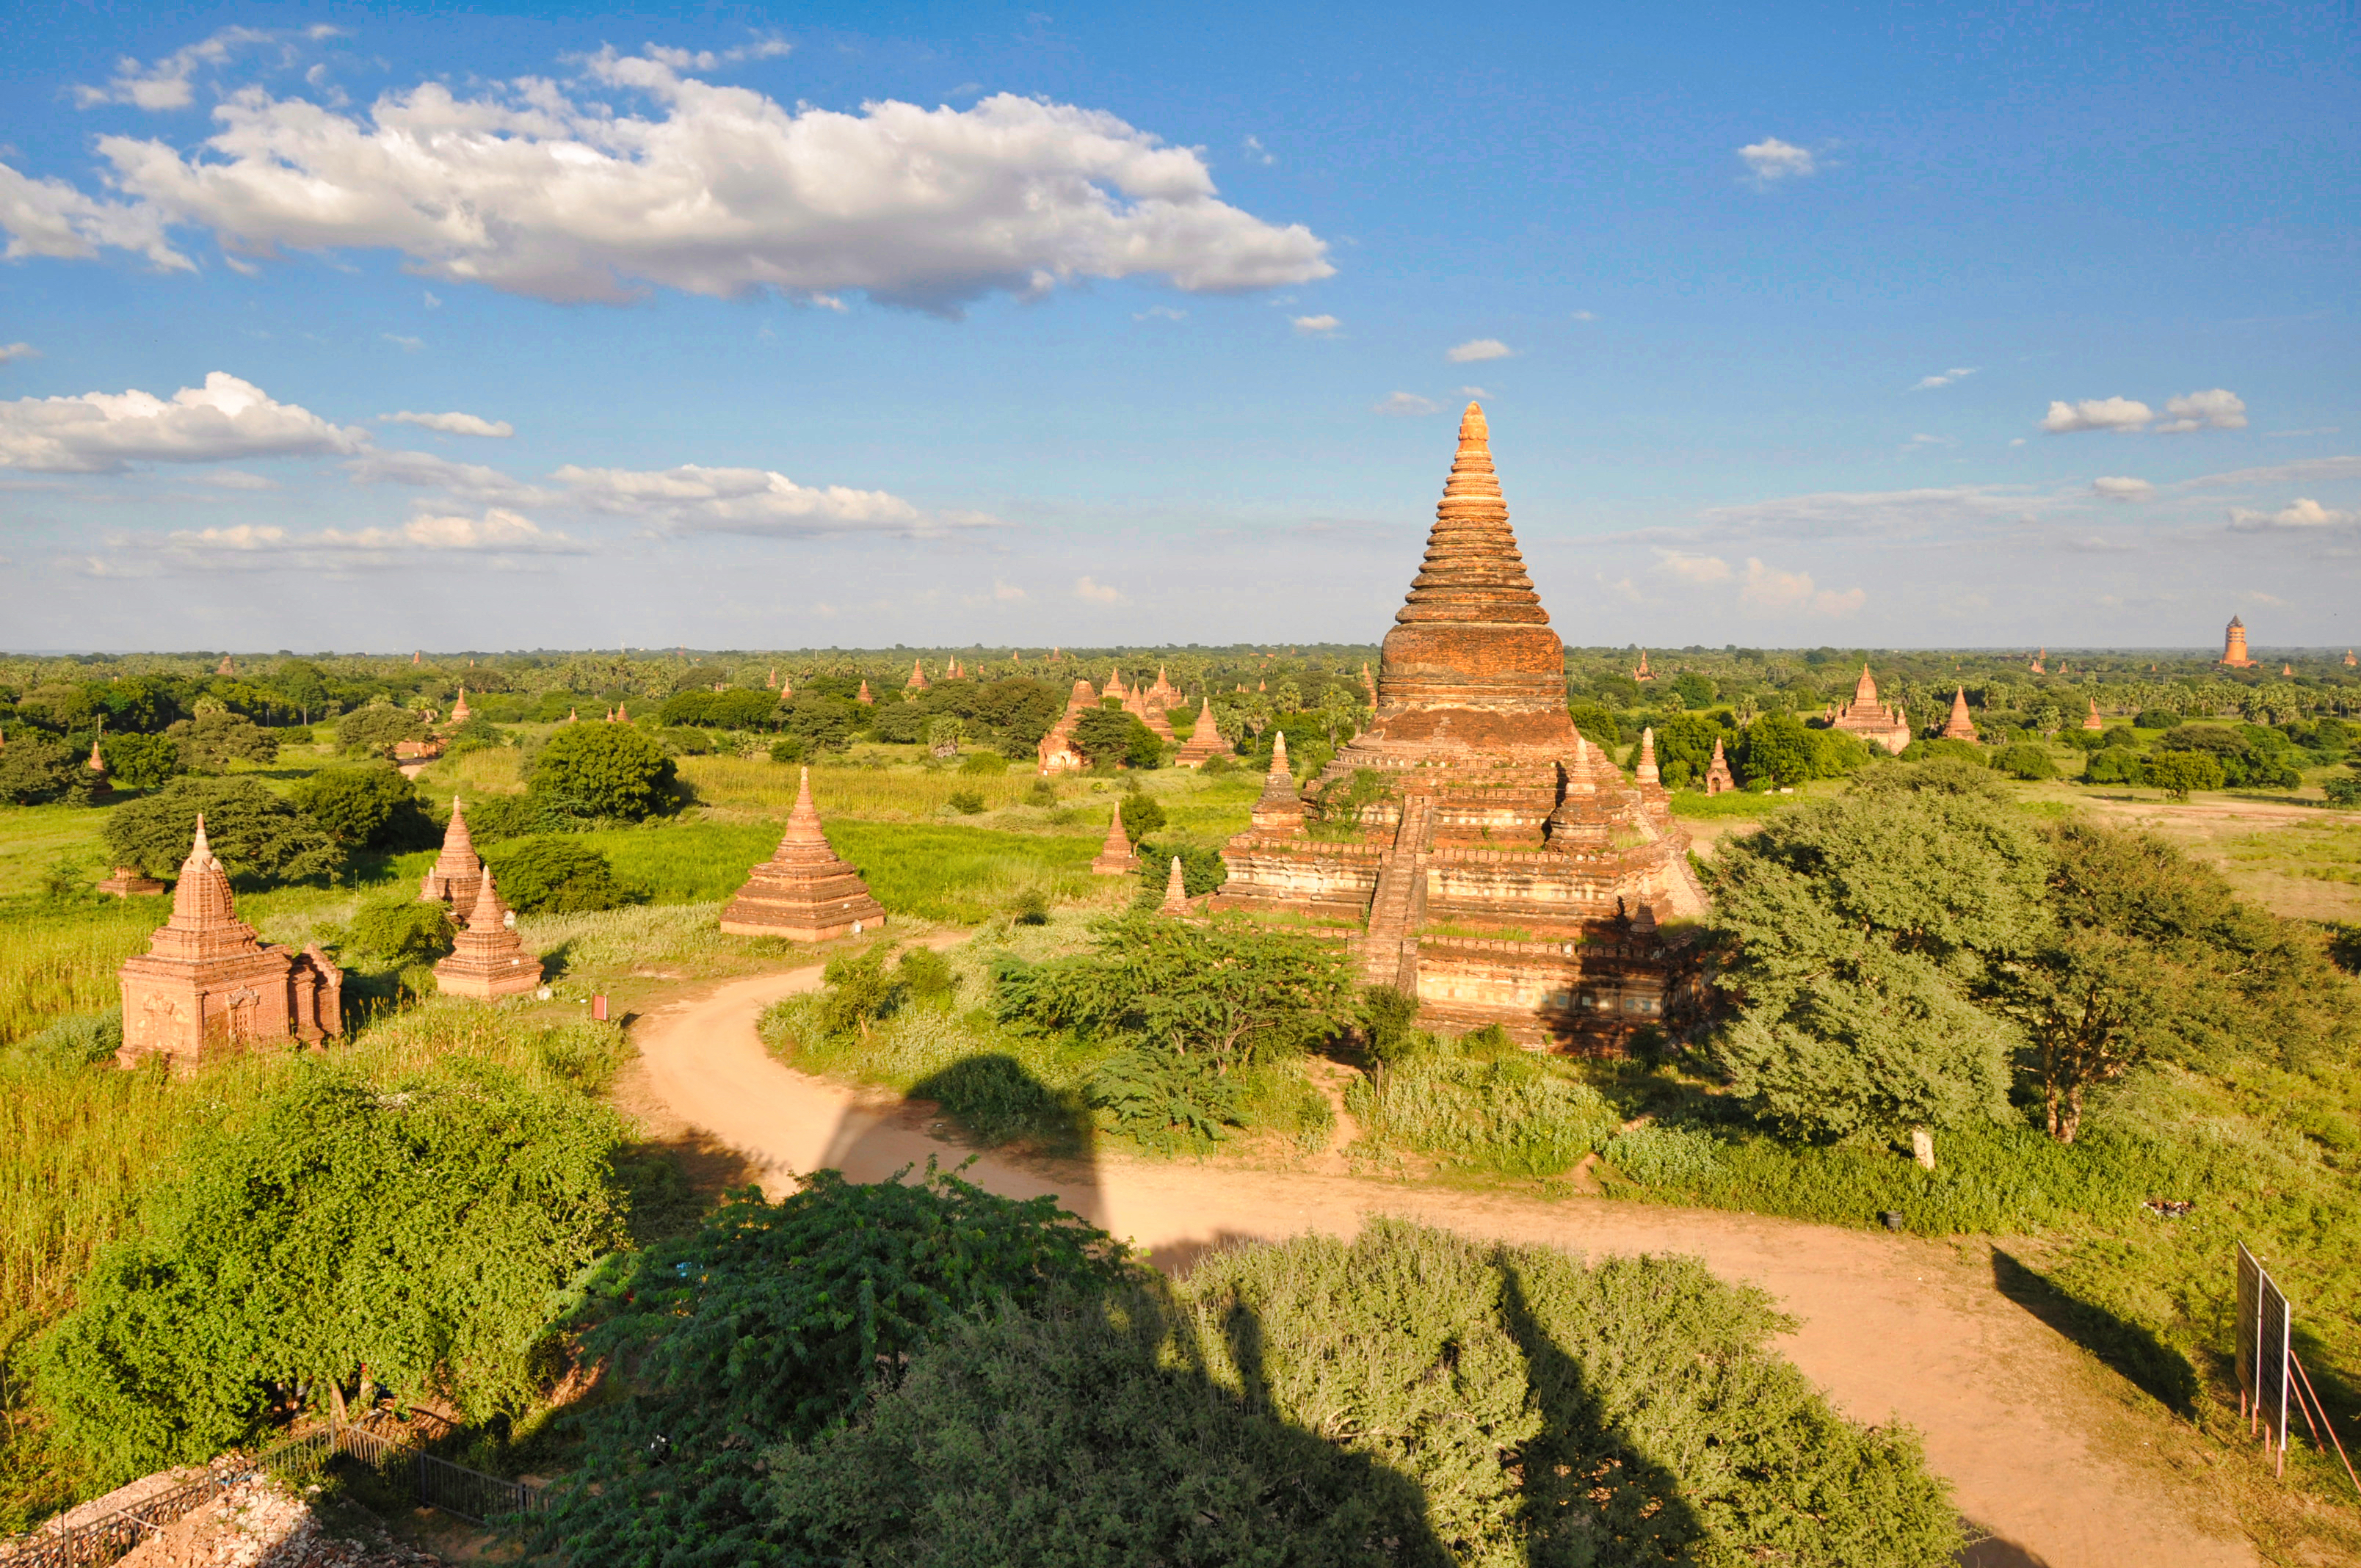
<box><xmin>1214</xmin><ymin>404</ymin><xmax>1705</xmax><ymax>1048</ymax></box>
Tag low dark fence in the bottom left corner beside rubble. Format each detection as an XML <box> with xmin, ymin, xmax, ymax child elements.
<box><xmin>0</xmin><ymin>1424</ymin><xmax>550</xmax><ymax>1568</ymax></box>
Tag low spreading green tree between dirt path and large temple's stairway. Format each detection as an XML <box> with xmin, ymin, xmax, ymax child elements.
<box><xmin>996</xmin><ymin>914</ymin><xmax>1360</xmax><ymax>1072</ymax></box>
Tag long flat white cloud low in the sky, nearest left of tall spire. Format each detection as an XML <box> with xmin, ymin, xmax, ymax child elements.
<box><xmin>550</xmin><ymin>465</ymin><xmax>963</xmax><ymax>536</ymax></box>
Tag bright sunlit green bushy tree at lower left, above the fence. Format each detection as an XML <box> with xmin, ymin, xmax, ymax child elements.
<box><xmin>35</xmin><ymin>1063</ymin><xmax>623</xmax><ymax>1478</ymax></box>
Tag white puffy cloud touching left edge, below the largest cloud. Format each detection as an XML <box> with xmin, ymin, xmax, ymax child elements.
<box><xmin>0</xmin><ymin>371</ymin><xmax>369</xmax><ymax>475</ymax></box>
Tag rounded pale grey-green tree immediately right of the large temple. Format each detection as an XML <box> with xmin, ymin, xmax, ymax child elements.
<box><xmin>1709</xmin><ymin>765</ymin><xmax>2047</xmax><ymax>1136</ymax></box>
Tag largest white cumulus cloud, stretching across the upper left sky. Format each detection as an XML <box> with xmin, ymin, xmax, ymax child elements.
<box><xmin>23</xmin><ymin>50</ymin><xmax>1334</xmax><ymax>314</ymax></box>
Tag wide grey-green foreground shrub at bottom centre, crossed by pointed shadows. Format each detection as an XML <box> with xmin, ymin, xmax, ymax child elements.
<box><xmin>760</xmin><ymin>1219</ymin><xmax>1959</xmax><ymax>1568</ymax></box>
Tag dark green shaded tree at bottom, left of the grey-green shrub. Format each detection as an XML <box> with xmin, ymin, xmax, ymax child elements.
<box><xmin>534</xmin><ymin>1169</ymin><xmax>1131</xmax><ymax>1568</ymax></box>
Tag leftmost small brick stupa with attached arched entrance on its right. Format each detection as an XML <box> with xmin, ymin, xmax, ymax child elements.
<box><xmin>116</xmin><ymin>817</ymin><xmax>345</xmax><ymax>1070</ymax></box>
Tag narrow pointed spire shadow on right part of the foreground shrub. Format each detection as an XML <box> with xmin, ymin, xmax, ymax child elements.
<box><xmin>1499</xmin><ymin>1259</ymin><xmax>1707</xmax><ymax>1568</ymax></box>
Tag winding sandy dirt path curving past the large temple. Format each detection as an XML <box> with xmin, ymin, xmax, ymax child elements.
<box><xmin>635</xmin><ymin>954</ymin><xmax>2260</xmax><ymax>1568</ymax></box>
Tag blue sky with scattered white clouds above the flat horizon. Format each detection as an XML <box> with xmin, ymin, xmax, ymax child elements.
<box><xmin>0</xmin><ymin>4</ymin><xmax>2361</xmax><ymax>650</ymax></box>
